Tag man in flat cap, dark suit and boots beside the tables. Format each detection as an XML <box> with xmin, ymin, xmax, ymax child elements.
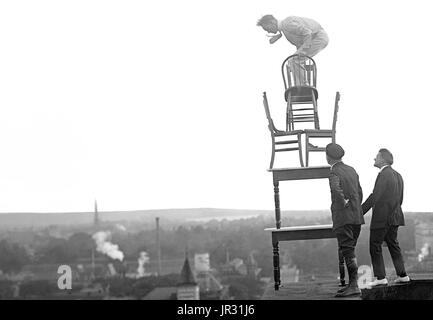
<box><xmin>326</xmin><ymin>143</ymin><xmax>364</xmax><ymax>297</ymax></box>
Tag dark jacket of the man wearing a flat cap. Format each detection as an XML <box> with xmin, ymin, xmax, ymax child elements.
<box><xmin>329</xmin><ymin>162</ymin><xmax>365</xmax><ymax>230</ymax></box>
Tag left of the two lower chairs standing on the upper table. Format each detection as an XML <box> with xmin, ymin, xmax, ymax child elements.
<box><xmin>263</xmin><ymin>92</ymin><xmax>304</xmax><ymax>169</ymax></box>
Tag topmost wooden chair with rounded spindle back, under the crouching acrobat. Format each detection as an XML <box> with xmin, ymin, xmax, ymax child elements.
<box><xmin>281</xmin><ymin>54</ymin><xmax>320</xmax><ymax>131</ymax></box>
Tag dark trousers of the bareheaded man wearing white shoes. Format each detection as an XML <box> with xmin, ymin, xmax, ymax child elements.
<box><xmin>370</xmin><ymin>226</ymin><xmax>406</xmax><ymax>280</ymax></box>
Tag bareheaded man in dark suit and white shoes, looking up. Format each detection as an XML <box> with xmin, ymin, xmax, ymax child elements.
<box><xmin>362</xmin><ymin>149</ymin><xmax>410</xmax><ymax>287</ymax></box>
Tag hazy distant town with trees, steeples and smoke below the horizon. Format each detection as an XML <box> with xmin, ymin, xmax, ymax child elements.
<box><xmin>0</xmin><ymin>208</ymin><xmax>433</xmax><ymax>300</ymax></box>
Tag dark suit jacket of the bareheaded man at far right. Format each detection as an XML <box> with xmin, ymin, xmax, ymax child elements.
<box><xmin>362</xmin><ymin>166</ymin><xmax>404</xmax><ymax>229</ymax></box>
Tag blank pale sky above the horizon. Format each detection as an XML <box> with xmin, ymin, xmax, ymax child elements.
<box><xmin>0</xmin><ymin>0</ymin><xmax>433</xmax><ymax>212</ymax></box>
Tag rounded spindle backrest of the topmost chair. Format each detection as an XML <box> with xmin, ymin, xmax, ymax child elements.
<box><xmin>281</xmin><ymin>54</ymin><xmax>317</xmax><ymax>91</ymax></box>
